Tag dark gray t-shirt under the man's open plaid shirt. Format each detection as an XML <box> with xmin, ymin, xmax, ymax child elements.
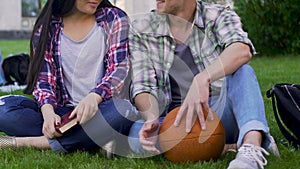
<box><xmin>169</xmin><ymin>44</ymin><xmax>199</xmax><ymax>111</ymax></box>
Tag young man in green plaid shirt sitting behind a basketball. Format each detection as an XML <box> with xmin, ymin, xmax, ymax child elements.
<box><xmin>129</xmin><ymin>0</ymin><xmax>279</xmax><ymax>169</ymax></box>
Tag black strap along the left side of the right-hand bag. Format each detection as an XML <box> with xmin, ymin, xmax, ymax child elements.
<box><xmin>267</xmin><ymin>88</ymin><xmax>300</xmax><ymax>147</ymax></box>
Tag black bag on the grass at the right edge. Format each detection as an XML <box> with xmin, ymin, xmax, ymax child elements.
<box><xmin>267</xmin><ymin>83</ymin><xmax>300</xmax><ymax>148</ymax></box>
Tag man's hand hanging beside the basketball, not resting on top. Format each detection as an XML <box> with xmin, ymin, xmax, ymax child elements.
<box><xmin>139</xmin><ymin>119</ymin><xmax>160</xmax><ymax>154</ymax></box>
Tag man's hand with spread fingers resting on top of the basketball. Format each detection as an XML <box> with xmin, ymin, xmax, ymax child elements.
<box><xmin>174</xmin><ymin>72</ymin><xmax>213</xmax><ymax>133</ymax></box>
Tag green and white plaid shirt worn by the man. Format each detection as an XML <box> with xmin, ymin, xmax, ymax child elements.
<box><xmin>129</xmin><ymin>1</ymin><xmax>255</xmax><ymax>110</ymax></box>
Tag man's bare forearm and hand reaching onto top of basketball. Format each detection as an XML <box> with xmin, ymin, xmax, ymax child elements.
<box><xmin>174</xmin><ymin>42</ymin><xmax>252</xmax><ymax>132</ymax></box>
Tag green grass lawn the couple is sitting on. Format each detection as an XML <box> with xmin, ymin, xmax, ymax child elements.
<box><xmin>0</xmin><ymin>40</ymin><xmax>300</xmax><ymax>169</ymax></box>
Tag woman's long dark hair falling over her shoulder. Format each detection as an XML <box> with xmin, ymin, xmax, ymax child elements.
<box><xmin>23</xmin><ymin>0</ymin><xmax>114</xmax><ymax>94</ymax></box>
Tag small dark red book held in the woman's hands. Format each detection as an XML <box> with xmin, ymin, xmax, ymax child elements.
<box><xmin>55</xmin><ymin>111</ymin><xmax>78</xmax><ymax>134</ymax></box>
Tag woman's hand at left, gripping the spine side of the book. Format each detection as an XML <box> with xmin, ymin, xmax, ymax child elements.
<box><xmin>41</xmin><ymin>104</ymin><xmax>62</xmax><ymax>138</ymax></box>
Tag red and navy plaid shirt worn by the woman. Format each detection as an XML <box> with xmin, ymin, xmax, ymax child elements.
<box><xmin>33</xmin><ymin>8</ymin><xmax>129</xmax><ymax>107</ymax></box>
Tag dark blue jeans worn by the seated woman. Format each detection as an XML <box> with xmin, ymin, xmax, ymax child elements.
<box><xmin>0</xmin><ymin>95</ymin><xmax>137</xmax><ymax>152</ymax></box>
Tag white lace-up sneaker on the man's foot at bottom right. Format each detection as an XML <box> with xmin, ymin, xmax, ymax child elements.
<box><xmin>228</xmin><ymin>144</ymin><xmax>269</xmax><ymax>169</ymax></box>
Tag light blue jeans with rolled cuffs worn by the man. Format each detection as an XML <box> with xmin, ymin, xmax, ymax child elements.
<box><xmin>128</xmin><ymin>64</ymin><xmax>274</xmax><ymax>154</ymax></box>
